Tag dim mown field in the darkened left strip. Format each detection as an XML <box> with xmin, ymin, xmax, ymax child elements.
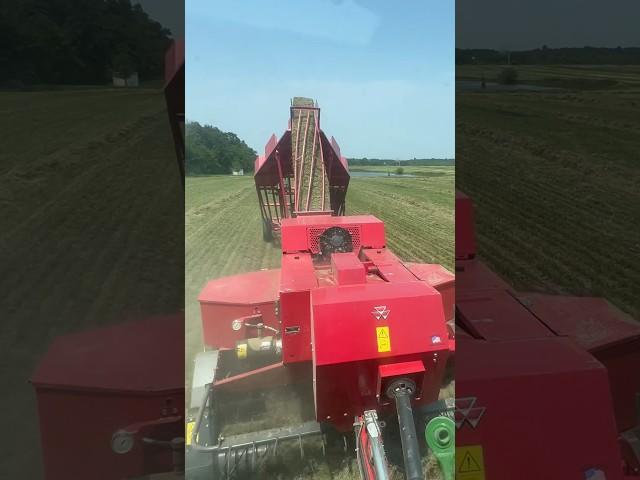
<box><xmin>0</xmin><ymin>89</ymin><xmax>183</xmax><ymax>479</ymax></box>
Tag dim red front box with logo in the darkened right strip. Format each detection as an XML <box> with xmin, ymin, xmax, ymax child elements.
<box><xmin>456</xmin><ymin>337</ymin><xmax>623</xmax><ymax>480</ymax></box>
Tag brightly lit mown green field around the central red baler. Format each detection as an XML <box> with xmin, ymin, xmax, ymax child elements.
<box><xmin>185</xmin><ymin>167</ymin><xmax>454</xmax><ymax>480</ymax></box>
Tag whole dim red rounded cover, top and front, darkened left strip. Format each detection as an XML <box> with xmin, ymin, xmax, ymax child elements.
<box><xmin>31</xmin><ymin>315</ymin><xmax>184</xmax><ymax>480</ymax></box>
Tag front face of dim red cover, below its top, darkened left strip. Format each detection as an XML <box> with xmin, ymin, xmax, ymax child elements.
<box><xmin>37</xmin><ymin>390</ymin><xmax>184</xmax><ymax>480</ymax></box>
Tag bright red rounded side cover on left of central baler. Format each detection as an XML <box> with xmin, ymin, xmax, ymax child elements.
<box><xmin>198</xmin><ymin>270</ymin><xmax>280</xmax><ymax>348</ymax></box>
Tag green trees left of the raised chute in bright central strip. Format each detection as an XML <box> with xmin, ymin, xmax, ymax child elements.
<box><xmin>185</xmin><ymin>122</ymin><xmax>256</xmax><ymax>175</ymax></box>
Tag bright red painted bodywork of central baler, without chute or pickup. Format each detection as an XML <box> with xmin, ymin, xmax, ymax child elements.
<box><xmin>200</xmin><ymin>214</ymin><xmax>453</xmax><ymax>431</ymax></box>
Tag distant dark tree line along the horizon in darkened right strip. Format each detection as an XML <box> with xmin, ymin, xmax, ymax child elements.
<box><xmin>456</xmin><ymin>45</ymin><xmax>640</xmax><ymax>65</ymax></box>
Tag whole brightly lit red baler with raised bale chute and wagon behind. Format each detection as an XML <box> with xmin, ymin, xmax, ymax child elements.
<box><xmin>187</xmin><ymin>102</ymin><xmax>454</xmax><ymax>479</ymax></box>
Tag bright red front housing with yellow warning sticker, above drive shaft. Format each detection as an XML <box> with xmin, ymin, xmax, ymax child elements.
<box><xmin>311</xmin><ymin>281</ymin><xmax>448</xmax><ymax>429</ymax></box>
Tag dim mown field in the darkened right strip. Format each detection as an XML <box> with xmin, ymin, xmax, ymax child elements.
<box><xmin>456</xmin><ymin>66</ymin><xmax>640</xmax><ymax>318</ymax></box>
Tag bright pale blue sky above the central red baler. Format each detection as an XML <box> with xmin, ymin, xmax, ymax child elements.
<box><xmin>185</xmin><ymin>0</ymin><xmax>455</xmax><ymax>159</ymax></box>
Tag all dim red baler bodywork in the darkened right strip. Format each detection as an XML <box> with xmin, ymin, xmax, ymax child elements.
<box><xmin>455</xmin><ymin>190</ymin><xmax>640</xmax><ymax>480</ymax></box>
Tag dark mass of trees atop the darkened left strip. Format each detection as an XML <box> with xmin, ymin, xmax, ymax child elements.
<box><xmin>0</xmin><ymin>0</ymin><xmax>171</xmax><ymax>87</ymax></box>
